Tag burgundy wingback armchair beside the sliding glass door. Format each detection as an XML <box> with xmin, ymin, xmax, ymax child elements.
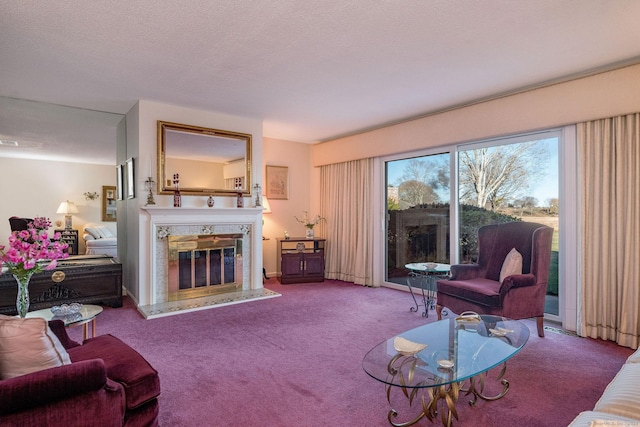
<box><xmin>436</xmin><ymin>222</ymin><xmax>553</xmax><ymax>337</ymax></box>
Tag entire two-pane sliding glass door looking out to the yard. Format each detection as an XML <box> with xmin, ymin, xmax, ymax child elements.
<box><xmin>385</xmin><ymin>131</ymin><xmax>561</xmax><ymax>316</ymax></box>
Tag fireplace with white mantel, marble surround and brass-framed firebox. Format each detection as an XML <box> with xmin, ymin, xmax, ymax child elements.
<box><xmin>139</xmin><ymin>206</ymin><xmax>263</xmax><ymax>306</ymax></box>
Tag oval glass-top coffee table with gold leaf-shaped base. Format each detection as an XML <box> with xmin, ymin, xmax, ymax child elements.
<box><xmin>362</xmin><ymin>309</ymin><xmax>529</xmax><ymax>426</ymax></box>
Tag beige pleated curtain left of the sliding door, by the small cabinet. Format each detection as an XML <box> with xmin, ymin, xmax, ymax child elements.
<box><xmin>320</xmin><ymin>159</ymin><xmax>374</xmax><ymax>286</ymax></box>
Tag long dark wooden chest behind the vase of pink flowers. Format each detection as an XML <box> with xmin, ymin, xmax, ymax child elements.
<box><xmin>0</xmin><ymin>255</ymin><xmax>122</xmax><ymax>315</ymax></box>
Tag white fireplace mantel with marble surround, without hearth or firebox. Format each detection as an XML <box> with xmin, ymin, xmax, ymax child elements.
<box><xmin>140</xmin><ymin>206</ymin><xmax>263</xmax><ymax>305</ymax></box>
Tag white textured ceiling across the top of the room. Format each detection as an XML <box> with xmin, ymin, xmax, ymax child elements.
<box><xmin>0</xmin><ymin>0</ymin><xmax>640</xmax><ymax>164</ymax></box>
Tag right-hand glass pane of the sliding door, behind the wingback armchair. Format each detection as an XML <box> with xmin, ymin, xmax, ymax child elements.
<box><xmin>458</xmin><ymin>131</ymin><xmax>561</xmax><ymax>316</ymax></box>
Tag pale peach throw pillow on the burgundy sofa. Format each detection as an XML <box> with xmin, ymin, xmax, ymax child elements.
<box><xmin>0</xmin><ymin>315</ymin><xmax>71</xmax><ymax>379</ymax></box>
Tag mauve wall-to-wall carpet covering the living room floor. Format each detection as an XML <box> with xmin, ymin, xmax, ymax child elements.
<box><xmin>70</xmin><ymin>279</ymin><xmax>632</xmax><ymax>427</ymax></box>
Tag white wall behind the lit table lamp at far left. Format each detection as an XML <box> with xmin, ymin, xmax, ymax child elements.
<box><xmin>0</xmin><ymin>158</ymin><xmax>116</xmax><ymax>254</ymax></box>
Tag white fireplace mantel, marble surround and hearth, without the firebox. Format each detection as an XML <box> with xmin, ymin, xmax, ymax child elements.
<box><xmin>139</xmin><ymin>206</ymin><xmax>277</xmax><ymax>318</ymax></box>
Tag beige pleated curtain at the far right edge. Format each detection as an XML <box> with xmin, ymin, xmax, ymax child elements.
<box><xmin>577</xmin><ymin>114</ymin><xmax>640</xmax><ymax>348</ymax></box>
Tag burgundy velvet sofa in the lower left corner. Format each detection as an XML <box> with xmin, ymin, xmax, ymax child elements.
<box><xmin>0</xmin><ymin>320</ymin><xmax>160</xmax><ymax>427</ymax></box>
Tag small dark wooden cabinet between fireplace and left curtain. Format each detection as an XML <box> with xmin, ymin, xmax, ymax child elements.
<box><xmin>278</xmin><ymin>237</ymin><xmax>326</xmax><ymax>284</ymax></box>
